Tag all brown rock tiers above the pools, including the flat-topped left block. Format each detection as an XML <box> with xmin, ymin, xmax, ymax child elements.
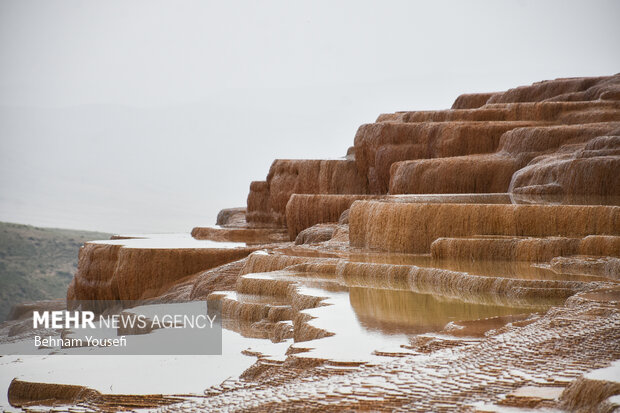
<box><xmin>67</xmin><ymin>74</ymin><xmax>620</xmax><ymax>338</ymax></box>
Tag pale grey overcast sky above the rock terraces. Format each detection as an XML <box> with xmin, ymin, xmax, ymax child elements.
<box><xmin>0</xmin><ymin>0</ymin><xmax>620</xmax><ymax>232</ymax></box>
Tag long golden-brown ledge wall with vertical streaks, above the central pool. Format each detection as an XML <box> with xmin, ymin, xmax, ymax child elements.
<box><xmin>349</xmin><ymin>201</ymin><xmax>620</xmax><ymax>253</ymax></box>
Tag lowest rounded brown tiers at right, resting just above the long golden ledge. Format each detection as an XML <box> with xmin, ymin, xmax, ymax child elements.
<box><xmin>389</xmin><ymin>122</ymin><xmax>620</xmax><ymax>196</ymax></box>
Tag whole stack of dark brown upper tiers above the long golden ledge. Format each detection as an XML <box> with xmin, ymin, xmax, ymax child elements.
<box><xmin>247</xmin><ymin>74</ymin><xmax>620</xmax><ymax>222</ymax></box>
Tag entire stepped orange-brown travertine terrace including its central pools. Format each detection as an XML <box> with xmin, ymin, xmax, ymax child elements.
<box><xmin>4</xmin><ymin>75</ymin><xmax>620</xmax><ymax>412</ymax></box>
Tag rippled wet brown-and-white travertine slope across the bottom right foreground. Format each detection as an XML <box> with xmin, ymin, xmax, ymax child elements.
<box><xmin>161</xmin><ymin>286</ymin><xmax>620</xmax><ymax>412</ymax></box>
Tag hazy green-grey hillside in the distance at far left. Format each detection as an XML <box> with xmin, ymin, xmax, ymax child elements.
<box><xmin>0</xmin><ymin>222</ymin><xmax>110</xmax><ymax>321</ymax></box>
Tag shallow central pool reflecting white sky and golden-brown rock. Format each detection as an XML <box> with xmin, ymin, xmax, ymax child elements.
<box><xmin>241</xmin><ymin>272</ymin><xmax>551</xmax><ymax>362</ymax></box>
